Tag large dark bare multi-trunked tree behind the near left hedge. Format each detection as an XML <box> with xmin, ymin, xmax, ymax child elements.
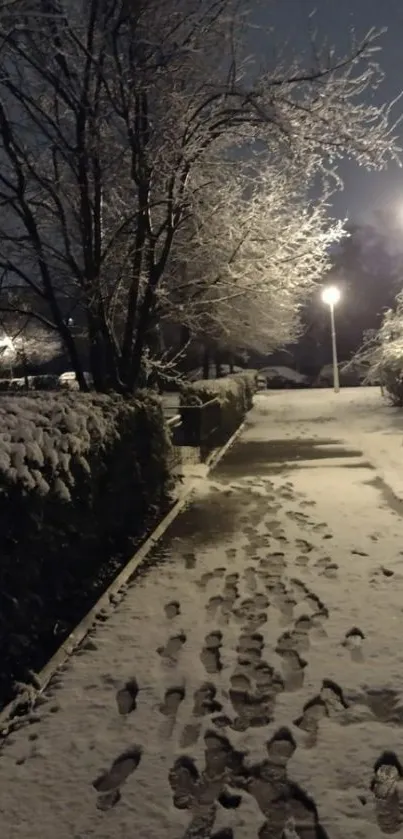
<box><xmin>0</xmin><ymin>0</ymin><xmax>397</xmax><ymax>392</ymax></box>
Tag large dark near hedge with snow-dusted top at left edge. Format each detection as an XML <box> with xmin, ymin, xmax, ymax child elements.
<box><xmin>0</xmin><ymin>393</ymin><xmax>171</xmax><ymax>696</ymax></box>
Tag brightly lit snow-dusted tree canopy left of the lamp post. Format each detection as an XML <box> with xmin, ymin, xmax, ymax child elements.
<box><xmin>159</xmin><ymin>161</ymin><xmax>343</xmax><ymax>353</ymax></box>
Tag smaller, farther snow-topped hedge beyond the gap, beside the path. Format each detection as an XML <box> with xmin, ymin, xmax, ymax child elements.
<box><xmin>180</xmin><ymin>370</ymin><xmax>257</xmax><ymax>440</ymax></box>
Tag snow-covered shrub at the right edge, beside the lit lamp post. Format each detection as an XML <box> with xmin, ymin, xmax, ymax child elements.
<box><xmin>347</xmin><ymin>292</ymin><xmax>403</xmax><ymax>407</ymax></box>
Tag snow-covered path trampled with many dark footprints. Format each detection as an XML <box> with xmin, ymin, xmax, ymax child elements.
<box><xmin>0</xmin><ymin>391</ymin><xmax>403</xmax><ymax>839</ymax></box>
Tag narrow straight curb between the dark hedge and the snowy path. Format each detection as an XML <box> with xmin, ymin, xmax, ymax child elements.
<box><xmin>0</xmin><ymin>422</ymin><xmax>245</xmax><ymax>736</ymax></box>
